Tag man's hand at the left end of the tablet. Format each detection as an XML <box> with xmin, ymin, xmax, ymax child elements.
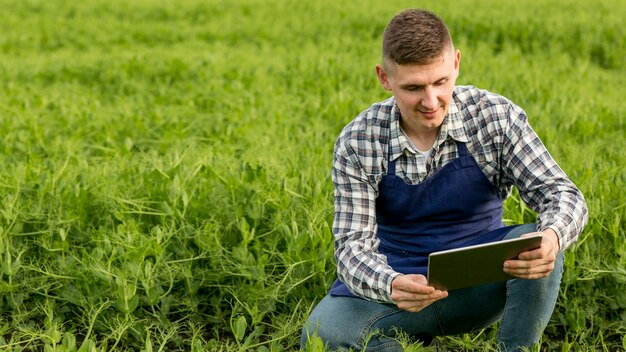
<box><xmin>391</xmin><ymin>274</ymin><xmax>448</xmax><ymax>312</ymax></box>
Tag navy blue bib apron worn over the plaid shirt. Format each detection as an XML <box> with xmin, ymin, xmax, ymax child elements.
<box><xmin>330</xmin><ymin>142</ymin><xmax>510</xmax><ymax>296</ymax></box>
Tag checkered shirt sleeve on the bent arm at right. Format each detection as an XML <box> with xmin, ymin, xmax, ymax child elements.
<box><xmin>502</xmin><ymin>105</ymin><xmax>588</xmax><ymax>251</ymax></box>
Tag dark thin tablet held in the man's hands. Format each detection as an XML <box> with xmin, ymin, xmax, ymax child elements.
<box><xmin>428</xmin><ymin>234</ymin><xmax>541</xmax><ymax>290</ymax></box>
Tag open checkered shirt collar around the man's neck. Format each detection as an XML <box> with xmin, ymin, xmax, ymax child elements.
<box><xmin>389</xmin><ymin>94</ymin><xmax>469</xmax><ymax>160</ymax></box>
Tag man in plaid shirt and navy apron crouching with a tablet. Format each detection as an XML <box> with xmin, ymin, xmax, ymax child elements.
<box><xmin>302</xmin><ymin>10</ymin><xmax>587</xmax><ymax>351</ymax></box>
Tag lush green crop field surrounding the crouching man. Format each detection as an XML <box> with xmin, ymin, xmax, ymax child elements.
<box><xmin>0</xmin><ymin>0</ymin><xmax>626</xmax><ymax>351</ymax></box>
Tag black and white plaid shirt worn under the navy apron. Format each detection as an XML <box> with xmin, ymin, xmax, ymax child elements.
<box><xmin>332</xmin><ymin>86</ymin><xmax>587</xmax><ymax>302</ymax></box>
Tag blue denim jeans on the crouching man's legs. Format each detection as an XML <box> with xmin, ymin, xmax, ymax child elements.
<box><xmin>301</xmin><ymin>224</ymin><xmax>563</xmax><ymax>351</ymax></box>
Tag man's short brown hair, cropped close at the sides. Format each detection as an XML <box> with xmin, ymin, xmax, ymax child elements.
<box><xmin>383</xmin><ymin>9</ymin><xmax>453</xmax><ymax>65</ymax></box>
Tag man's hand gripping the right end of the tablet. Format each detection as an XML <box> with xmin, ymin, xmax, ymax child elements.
<box><xmin>503</xmin><ymin>229</ymin><xmax>559</xmax><ymax>279</ymax></box>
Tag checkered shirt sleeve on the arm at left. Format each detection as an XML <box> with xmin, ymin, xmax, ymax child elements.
<box><xmin>332</xmin><ymin>138</ymin><xmax>399</xmax><ymax>302</ymax></box>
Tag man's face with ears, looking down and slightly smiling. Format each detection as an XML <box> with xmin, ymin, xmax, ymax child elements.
<box><xmin>376</xmin><ymin>49</ymin><xmax>461</xmax><ymax>134</ymax></box>
